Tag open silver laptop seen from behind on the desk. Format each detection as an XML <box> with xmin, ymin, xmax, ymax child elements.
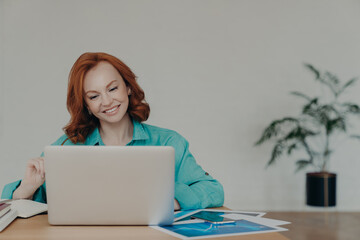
<box><xmin>44</xmin><ymin>146</ymin><xmax>175</xmax><ymax>225</ymax></box>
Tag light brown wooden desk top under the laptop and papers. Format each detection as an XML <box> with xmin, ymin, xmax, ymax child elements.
<box><xmin>0</xmin><ymin>215</ymin><xmax>288</xmax><ymax>240</ymax></box>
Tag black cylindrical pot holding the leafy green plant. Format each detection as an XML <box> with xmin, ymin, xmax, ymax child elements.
<box><xmin>306</xmin><ymin>172</ymin><xmax>336</xmax><ymax>207</ymax></box>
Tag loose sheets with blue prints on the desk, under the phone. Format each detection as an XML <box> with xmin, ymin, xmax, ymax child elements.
<box><xmin>153</xmin><ymin>209</ymin><xmax>290</xmax><ymax>239</ymax></box>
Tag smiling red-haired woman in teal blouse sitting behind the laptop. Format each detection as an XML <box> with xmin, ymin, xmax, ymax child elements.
<box><xmin>2</xmin><ymin>53</ymin><xmax>224</xmax><ymax>210</ymax></box>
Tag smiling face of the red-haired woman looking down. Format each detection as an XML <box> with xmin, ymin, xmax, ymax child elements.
<box><xmin>84</xmin><ymin>61</ymin><xmax>130</xmax><ymax>125</ymax></box>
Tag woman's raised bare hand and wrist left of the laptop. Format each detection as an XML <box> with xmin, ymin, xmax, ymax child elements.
<box><xmin>13</xmin><ymin>157</ymin><xmax>45</xmax><ymax>199</ymax></box>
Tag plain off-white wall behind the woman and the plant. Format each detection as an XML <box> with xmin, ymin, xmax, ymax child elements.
<box><xmin>0</xmin><ymin>0</ymin><xmax>360</xmax><ymax>211</ymax></box>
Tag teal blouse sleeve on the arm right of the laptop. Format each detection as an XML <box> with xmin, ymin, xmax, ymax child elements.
<box><xmin>168</xmin><ymin>134</ymin><xmax>224</xmax><ymax>210</ymax></box>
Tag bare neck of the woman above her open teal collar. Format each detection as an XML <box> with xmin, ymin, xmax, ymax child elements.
<box><xmin>99</xmin><ymin>114</ymin><xmax>134</xmax><ymax>146</ymax></box>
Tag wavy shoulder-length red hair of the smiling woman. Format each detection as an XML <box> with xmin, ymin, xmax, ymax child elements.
<box><xmin>63</xmin><ymin>52</ymin><xmax>150</xmax><ymax>143</ymax></box>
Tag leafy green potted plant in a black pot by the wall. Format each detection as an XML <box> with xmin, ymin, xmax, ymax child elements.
<box><xmin>255</xmin><ymin>64</ymin><xmax>360</xmax><ymax>206</ymax></box>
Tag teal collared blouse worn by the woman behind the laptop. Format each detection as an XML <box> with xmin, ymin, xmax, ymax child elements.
<box><xmin>1</xmin><ymin>121</ymin><xmax>224</xmax><ymax>210</ymax></box>
